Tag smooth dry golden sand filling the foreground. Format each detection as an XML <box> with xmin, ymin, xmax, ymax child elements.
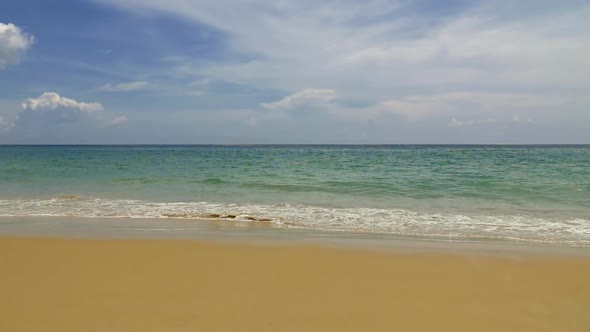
<box><xmin>0</xmin><ymin>237</ymin><xmax>590</xmax><ymax>331</ymax></box>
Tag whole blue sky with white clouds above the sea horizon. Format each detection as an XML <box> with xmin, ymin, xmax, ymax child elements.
<box><xmin>0</xmin><ymin>0</ymin><xmax>590</xmax><ymax>144</ymax></box>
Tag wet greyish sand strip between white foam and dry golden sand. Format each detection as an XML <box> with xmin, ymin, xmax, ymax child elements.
<box><xmin>0</xmin><ymin>216</ymin><xmax>590</xmax><ymax>258</ymax></box>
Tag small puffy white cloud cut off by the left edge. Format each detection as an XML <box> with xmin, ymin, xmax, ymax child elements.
<box><xmin>0</xmin><ymin>22</ymin><xmax>35</xmax><ymax>69</ymax></box>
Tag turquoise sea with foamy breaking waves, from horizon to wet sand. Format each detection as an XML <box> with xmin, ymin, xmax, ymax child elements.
<box><xmin>0</xmin><ymin>146</ymin><xmax>590</xmax><ymax>246</ymax></box>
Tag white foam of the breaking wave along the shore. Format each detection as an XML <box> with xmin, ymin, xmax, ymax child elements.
<box><xmin>0</xmin><ymin>196</ymin><xmax>590</xmax><ymax>246</ymax></box>
